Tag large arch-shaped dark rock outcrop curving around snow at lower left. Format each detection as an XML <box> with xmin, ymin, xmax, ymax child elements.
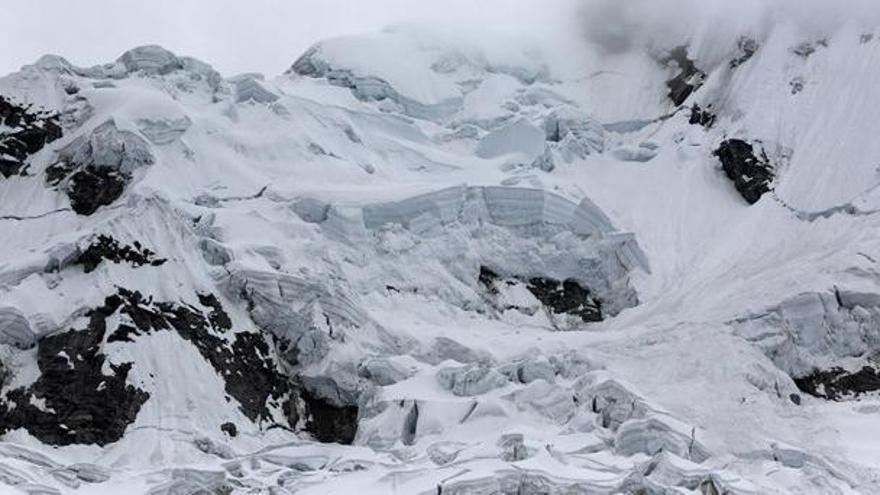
<box><xmin>0</xmin><ymin>288</ymin><xmax>318</xmax><ymax>445</ymax></box>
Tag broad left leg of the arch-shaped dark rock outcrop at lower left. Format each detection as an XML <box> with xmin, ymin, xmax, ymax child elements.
<box><xmin>0</xmin><ymin>296</ymin><xmax>149</xmax><ymax>446</ymax></box>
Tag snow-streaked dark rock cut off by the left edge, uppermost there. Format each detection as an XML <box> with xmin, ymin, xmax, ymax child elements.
<box><xmin>0</xmin><ymin>95</ymin><xmax>62</xmax><ymax>178</ymax></box>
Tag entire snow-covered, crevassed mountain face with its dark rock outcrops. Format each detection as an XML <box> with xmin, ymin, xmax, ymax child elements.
<box><xmin>0</xmin><ymin>13</ymin><xmax>880</xmax><ymax>494</ymax></box>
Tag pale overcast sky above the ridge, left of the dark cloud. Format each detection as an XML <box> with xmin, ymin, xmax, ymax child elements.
<box><xmin>0</xmin><ymin>0</ymin><xmax>576</xmax><ymax>76</ymax></box>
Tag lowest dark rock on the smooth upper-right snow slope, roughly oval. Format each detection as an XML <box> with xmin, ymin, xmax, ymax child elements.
<box><xmin>715</xmin><ymin>139</ymin><xmax>774</xmax><ymax>204</ymax></box>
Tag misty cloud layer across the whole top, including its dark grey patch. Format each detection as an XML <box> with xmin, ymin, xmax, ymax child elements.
<box><xmin>6</xmin><ymin>0</ymin><xmax>880</xmax><ymax>75</ymax></box>
